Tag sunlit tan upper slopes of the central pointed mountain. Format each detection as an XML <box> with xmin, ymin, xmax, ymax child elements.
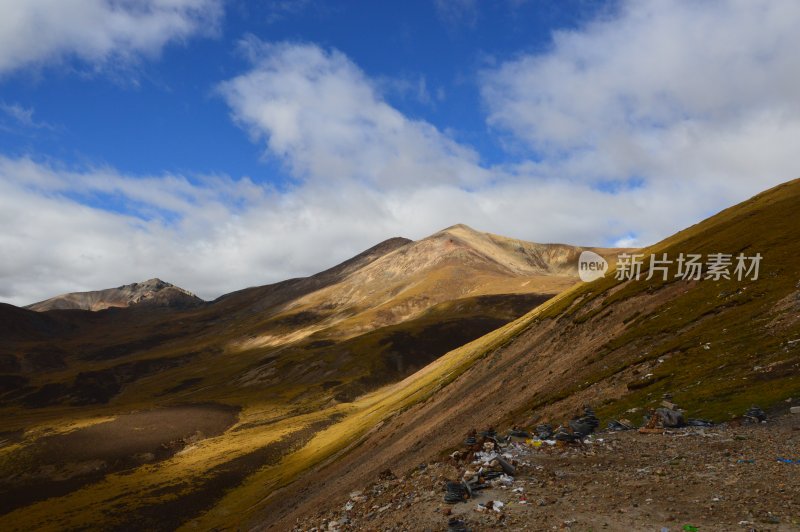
<box><xmin>245</xmin><ymin>224</ymin><xmax>619</xmax><ymax>342</ymax></box>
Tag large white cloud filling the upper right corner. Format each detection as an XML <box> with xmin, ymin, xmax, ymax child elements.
<box><xmin>481</xmin><ymin>0</ymin><xmax>800</xmax><ymax>197</ymax></box>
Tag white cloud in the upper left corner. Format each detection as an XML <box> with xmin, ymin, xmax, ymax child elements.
<box><xmin>0</xmin><ymin>0</ymin><xmax>222</xmax><ymax>75</ymax></box>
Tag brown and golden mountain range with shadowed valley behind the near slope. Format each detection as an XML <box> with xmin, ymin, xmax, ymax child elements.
<box><xmin>0</xmin><ymin>225</ymin><xmax>618</xmax><ymax>530</ymax></box>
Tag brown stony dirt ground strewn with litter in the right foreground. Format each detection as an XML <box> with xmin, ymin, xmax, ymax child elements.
<box><xmin>295</xmin><ymin>415</ymin><xmax>800</xmax><ymax>532</ymax></box>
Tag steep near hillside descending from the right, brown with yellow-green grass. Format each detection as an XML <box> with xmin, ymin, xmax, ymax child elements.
<box><xmin>234</xmin><ymin>180</ymin><xmax>800</xmax><ymax>529</ymax></box>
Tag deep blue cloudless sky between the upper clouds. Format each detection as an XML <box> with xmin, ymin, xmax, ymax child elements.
<box><xmin>0</xmin><ymin>0</ymin><xmax>604</xmax><ymax>181</ymax></box>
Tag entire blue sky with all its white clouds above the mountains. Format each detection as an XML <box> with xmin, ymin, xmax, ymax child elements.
<box><xmin>0</xmin><ymin>0</ymin><xmax>800</xmax><ymax>304</ymax></box>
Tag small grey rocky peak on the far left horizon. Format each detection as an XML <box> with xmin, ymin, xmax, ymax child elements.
<box><xmin>25</xmin><ymin>279</ymin><xmax>204</xmax><ymax>312</ymax></box>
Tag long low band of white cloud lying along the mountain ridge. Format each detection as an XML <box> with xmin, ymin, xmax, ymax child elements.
<box><xmin>0</xmin><ymin>157</ymin><xmax>641</xmax><ymax>305</ymax></box>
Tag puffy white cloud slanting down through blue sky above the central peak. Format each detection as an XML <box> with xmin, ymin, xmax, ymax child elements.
<box><xmin>219</xmin><ymin>39</ymin><xmax>490</xmax><ymax>189</ymax></box>
